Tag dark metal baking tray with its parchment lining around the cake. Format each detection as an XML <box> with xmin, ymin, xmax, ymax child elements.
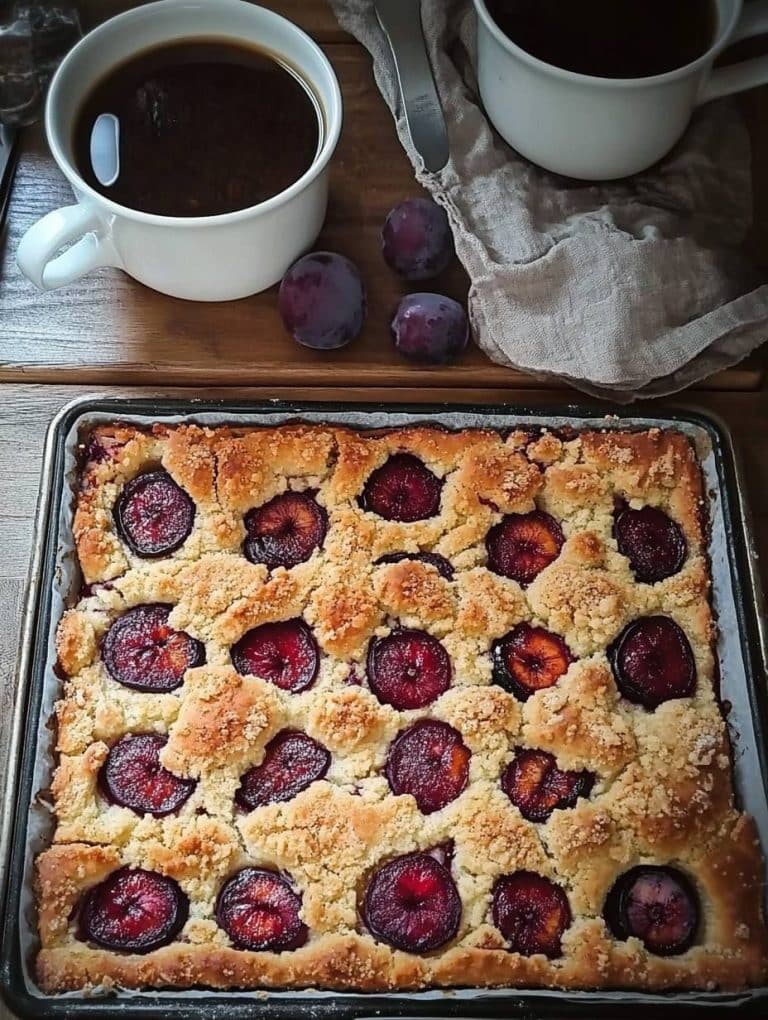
<box><xmin>0</xmin><ymin>397</ymin><xmax>768</xmax><ymax>1020</ymax></box>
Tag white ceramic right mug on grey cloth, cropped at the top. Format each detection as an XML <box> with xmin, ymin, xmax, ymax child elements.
<box><xmin>474</xmin><ymin>0</ymin><xmax>768</xmax><ymax>181</ymax></box>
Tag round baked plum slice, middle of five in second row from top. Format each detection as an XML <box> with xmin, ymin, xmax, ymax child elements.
<box><xmin>367</xmin><ymin>629</ymin><xmax>451</xmax><ymax>712</ymax></box>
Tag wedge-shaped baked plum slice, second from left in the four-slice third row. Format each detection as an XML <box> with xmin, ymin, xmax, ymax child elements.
<box><xmin>235</xmin><ymin>729</ymin><xmax>330</xmax><ymax>811</ymax></box>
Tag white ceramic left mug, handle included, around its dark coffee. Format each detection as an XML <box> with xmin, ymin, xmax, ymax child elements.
<box><xmin>16</xmin><ymin>0</ymin><xmax>342</xmax><ymax>301</ymax></box>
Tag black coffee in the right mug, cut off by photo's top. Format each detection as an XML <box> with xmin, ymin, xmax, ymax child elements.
<box><xmin>487</xmin><ymin>0</ymin><xmax>718</xmax><ymax>78</ymax></box>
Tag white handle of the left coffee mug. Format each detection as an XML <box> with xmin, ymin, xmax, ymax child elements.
<box><xmin>16</xmin><ymin>205</ymin><xmax>122</xmax><ymax>291</ymax></box>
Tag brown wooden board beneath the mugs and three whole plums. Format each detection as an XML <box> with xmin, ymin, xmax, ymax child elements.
<box><xmin>0</xmin><ymin>0</ymin><xmax>768</xmax><ymax>390</ymax></box>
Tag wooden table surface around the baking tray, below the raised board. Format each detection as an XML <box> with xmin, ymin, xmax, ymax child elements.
<box><xmin>0</xmin><ymin>384</ymin><xmax>768</xmax><ymax>1020</ymax></box>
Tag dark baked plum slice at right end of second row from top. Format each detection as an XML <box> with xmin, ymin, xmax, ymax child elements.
<box><xmin>609</xmin><ymin>616</ymin><xmax>696</xmax><ymax>710</ymax></box>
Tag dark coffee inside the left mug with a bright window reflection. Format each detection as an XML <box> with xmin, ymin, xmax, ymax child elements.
<box><xmin>74</xmin><ymin>40</ymin><xmax>320</xmax><ymax>216</ymax></box>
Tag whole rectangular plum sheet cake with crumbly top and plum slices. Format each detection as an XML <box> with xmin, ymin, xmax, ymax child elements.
<box><xmin>37</xmin><ymin>424</ymin><xmax>768</xmax><ymax>992</ymax></box>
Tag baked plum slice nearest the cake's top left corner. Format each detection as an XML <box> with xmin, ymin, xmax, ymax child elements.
<box><xmin>114</xmin><ymin>470</ymin><xmax>195</xmax><ymax>559</ymax></box>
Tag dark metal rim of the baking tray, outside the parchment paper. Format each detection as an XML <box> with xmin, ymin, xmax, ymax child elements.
<box><xmin>0</xmin><ymin>391</ymin><xmax>768</xmax><ymax>1020</ymax></box>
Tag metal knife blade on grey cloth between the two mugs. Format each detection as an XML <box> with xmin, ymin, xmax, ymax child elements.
<box><xmin>374</xmin><ymin>0</ymin><xmax>451</xmax><ymax>173</ymax></box>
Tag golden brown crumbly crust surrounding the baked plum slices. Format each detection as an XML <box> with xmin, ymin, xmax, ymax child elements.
<box><xmin>37</xmin><ymin>425</ymin><xmax>768</xmax><ymax>992</ymax></box>
